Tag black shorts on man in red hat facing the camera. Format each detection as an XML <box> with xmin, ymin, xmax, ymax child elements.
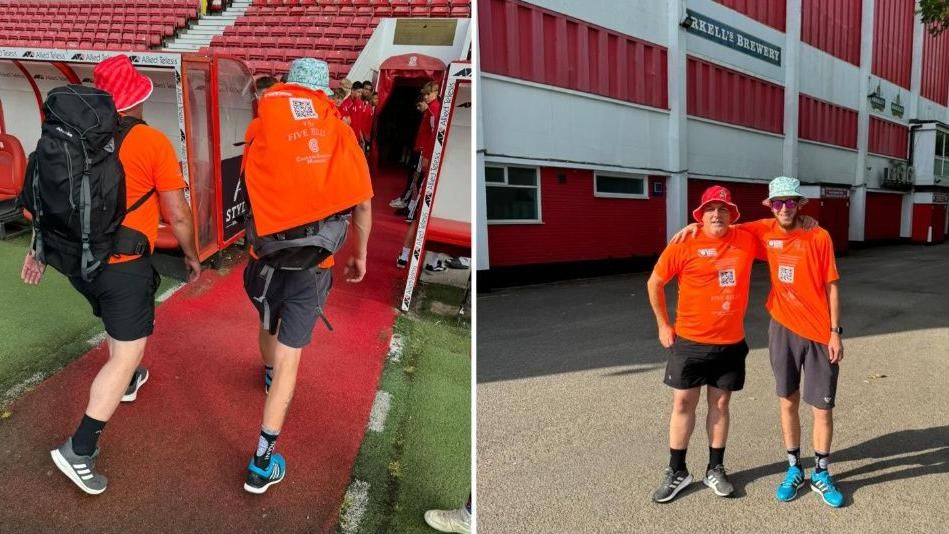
<box><xmin>663</xmin><ymin>337</ymin><xmax>748</xmax><ymax>391</ymax></box>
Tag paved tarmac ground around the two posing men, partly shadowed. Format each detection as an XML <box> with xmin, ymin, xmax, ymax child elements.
<box><xmin>477</xmin><ymin>244</ymin><xmax>949</xmax><ymax>534</ymax></box>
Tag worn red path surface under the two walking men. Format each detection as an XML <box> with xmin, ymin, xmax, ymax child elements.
<box><xmin>0</xmin><ymin>173</ymin><xmax>406</xmax><ymax>533</ymax></box>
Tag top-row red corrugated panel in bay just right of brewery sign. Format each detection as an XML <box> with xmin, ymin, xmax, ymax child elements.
<box><xmin>801</xmin><ymin>0</ymin><xmax>863</xmax><ymax>65</ymax></box>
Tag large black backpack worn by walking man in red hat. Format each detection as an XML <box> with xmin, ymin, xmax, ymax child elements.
<box><xmin>20</xmin><ymin>85</ymin><xmax>155</xmax><ymax>281</ymax></box>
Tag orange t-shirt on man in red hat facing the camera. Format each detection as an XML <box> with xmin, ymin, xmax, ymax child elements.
<box><xmin>653</xmin><ymin>229</ymin><xmax>763</xmax><ymax>345</ymax></box>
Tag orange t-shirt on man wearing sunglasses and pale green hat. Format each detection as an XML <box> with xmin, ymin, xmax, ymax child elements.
<box><xmin>741</xmin><ymin>219</ymin><xmax>840</xmax><ymax>345</ymax></box>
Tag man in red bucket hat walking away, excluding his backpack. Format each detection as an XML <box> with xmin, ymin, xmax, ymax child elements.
<box><xmin>21</xmin><ymin>55</ymin><xmax>201</xmax><ymax>495</ymax></box>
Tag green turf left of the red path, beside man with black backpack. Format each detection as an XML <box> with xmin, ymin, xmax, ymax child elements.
<box><xmin>0</xmin><ymin>235</ymin><xmax>177</xmax><ymax>408</ymax></box>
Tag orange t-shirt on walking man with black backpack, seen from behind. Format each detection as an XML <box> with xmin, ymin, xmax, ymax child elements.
<box><xmin>109</xmin><ymin>124</ymin><xmax>187</xmax><ymax>263</ymax></box>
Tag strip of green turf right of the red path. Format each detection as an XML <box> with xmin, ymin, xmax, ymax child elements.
<box><xmin>340</xmin><ymin>288</ymin><xmax>471</xmax><ymax>534</ymax></box>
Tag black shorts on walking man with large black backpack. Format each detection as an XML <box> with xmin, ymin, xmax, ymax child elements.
<box><xmin>69</xmin><ymin>257</ymin><xmax>161</xmax><ymax>341</ymax></box>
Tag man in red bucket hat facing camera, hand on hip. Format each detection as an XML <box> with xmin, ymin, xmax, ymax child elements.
<box><xmin>648</xmin><ymin>186</ymin><xmax>764</xmax><ymax>502</ymax></box>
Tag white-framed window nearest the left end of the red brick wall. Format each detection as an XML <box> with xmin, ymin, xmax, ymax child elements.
<box><xmin>484</xmin><ymin>164</ymin><xmax>540</xmax><ymax>222</ymax></box>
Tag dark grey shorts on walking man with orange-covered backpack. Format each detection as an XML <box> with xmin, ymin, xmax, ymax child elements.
<box><xmin>244</xmin><ymin>259</ymin><xmax>333</xmax><ymax>349</ymax></box>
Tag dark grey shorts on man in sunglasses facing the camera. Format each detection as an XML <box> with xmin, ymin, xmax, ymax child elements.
<box><xmin>768</xmin><ymin>319</ymin><xmax>839</xmax><ymax>410</ymax></box>
